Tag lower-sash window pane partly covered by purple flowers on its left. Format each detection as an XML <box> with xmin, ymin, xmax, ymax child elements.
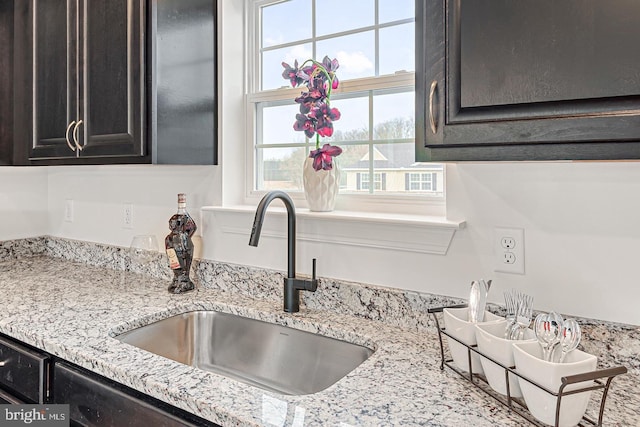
<box><xmin>324</xmin><ymin>97</ymin><xmax>369</xmax><ymax>144</ymax></box>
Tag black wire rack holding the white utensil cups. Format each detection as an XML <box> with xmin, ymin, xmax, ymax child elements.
<box><xmin>427</xmin><ymin>304</ymin><xmax>627</xmax><ymax>427</ymax></box>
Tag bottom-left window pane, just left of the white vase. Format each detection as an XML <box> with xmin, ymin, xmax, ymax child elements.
<box><xmin>256</xmin><ymin>147</ymin><xmax>306</xmax><ymax>190</ymax></box>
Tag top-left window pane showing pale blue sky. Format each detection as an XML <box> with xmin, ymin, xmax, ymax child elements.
<box><xmin>261</xmin><ymin>0</ymin><xmax>311</xmax><ymax>47</ymax></box>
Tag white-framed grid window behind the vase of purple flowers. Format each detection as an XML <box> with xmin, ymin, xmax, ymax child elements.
<box><xmin>247</xmin><ymin>0</ymin><xmax>444</xmax><ymax>206</ymax></box>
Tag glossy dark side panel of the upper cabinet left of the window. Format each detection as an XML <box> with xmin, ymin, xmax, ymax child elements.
<box><xmin>148</xmin><ymin>0</ymin><xmax>218</xmax><ymax>165</ymax></box>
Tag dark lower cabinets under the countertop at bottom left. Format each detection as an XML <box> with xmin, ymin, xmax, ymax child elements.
<box><xmin>0</xmin><ymin>335</ymin><xmax>216</xmax><ymax>427</ymax></box>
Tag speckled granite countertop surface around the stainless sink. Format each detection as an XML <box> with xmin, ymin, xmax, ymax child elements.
<box><xmin>0</xmin><ymin>256</ymin><xmax>639</xmax><ymax>427</ymax></box>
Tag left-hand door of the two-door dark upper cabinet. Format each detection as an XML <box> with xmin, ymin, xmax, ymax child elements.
<box><xmin>29</xmin><ymin>0</ymin><xmax>79</xmax><ymax>159</ymax></box>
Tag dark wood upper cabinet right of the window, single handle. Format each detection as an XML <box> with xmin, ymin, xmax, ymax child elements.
<box><xmin>416</xmin><ymin>0</ymin><xmax>640</xmax><ymax>161</ymax></box>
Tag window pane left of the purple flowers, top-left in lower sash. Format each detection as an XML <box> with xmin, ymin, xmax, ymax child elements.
<box><xmin>258</xmin><ymin>101</ymin><xmax>305</xmax><ymax>144</ymax></box>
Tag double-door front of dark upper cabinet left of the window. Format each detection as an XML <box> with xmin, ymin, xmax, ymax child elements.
<box><xmin>15</xmin><ymin>0</ymin><xmax>149</xmax><ymax>164</ymax></box>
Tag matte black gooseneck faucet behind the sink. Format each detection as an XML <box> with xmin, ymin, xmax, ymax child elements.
<box><xmin>249</xmin><ymin>191</ymin><xmax>318</xmax><ymax>313</ymax></box>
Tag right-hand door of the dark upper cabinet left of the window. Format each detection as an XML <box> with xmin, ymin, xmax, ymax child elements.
<box><xmin>79</xmin><ymin>0</ymin><xmax>145</xmax><ymax>157</ymax></box>
